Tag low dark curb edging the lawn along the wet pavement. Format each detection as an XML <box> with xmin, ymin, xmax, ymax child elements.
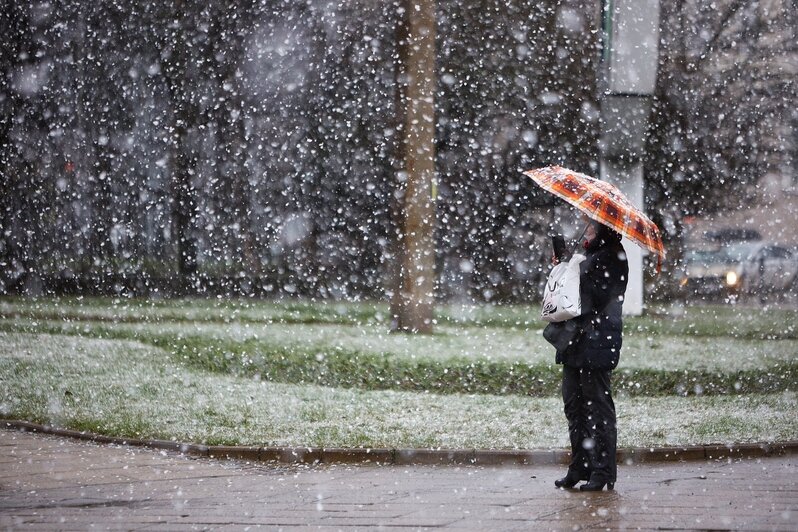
<box><xmin>0</xmin><ymin>419</ymin><xmax>798</xmax><ymax>466</ymax></box>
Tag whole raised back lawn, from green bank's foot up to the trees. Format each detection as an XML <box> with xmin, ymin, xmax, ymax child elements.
<box><xmin>0</xmin><ymin>301</ymin><xmax>798</xmax><ymax>396</ymax></box>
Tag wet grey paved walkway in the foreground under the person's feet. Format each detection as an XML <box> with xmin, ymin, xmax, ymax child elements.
<box><xmin>0</xmin><ymin>430</ymin><xmax>798</xmax><ymax>531</ymax></box>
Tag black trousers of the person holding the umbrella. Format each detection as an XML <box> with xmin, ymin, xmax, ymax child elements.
<box><xmin>562</xmin><ymin>366</ymin><xmax>618</xmax><ymax>482</ymax></box>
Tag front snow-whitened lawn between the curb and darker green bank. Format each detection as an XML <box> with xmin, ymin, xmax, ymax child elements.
<box><xmin>0</xmin><ymin>332</ymin><xmax>798</xmax><ymax>449</ymax></box>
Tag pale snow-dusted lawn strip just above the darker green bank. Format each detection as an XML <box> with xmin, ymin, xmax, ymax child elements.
<box><xmin>10</xmin><ymin>319</ymin><xmax>798</xmax><ymax>371</ymax></box>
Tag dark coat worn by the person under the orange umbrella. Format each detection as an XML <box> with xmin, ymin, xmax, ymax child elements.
<box><xmin>556</xmin><ymin>233</ymin><xmax>629</xmax><ymax>370</ymax></box>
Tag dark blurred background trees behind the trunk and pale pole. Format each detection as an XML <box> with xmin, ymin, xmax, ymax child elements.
<box><xmin>0</xmin><ymin>0</ymin><xmax>798</xmax><ymax>301</ymax></box>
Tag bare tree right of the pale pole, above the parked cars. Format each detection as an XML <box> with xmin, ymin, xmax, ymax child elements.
<box><xmin>647</xmin><ymin>0</ymin><xmax>798</xmax><ymax>218</ymax></box>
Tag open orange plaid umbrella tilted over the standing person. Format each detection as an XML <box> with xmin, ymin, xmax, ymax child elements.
<box><xmin>524</xmin><ymin>166</ymin><xmax>665</xmax><ymax>272</ymax></box>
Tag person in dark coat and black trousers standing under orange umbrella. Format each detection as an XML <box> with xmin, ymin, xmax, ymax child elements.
<box><xmin>554</xmin><ymin>220</ymin><xmax>629</xmax><ymax>491</ymax></box>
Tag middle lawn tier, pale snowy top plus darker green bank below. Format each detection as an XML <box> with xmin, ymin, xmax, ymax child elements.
<box><xmin>0</xmin><ymin>310</ymin><xmax>798</xmax><ymax>396</ymax></box>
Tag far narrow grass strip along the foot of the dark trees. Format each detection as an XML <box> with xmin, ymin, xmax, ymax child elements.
<box><xmin>0</xmin><ymin>297</ymin><xmax>798</xmax><ymax>340</ymax></box>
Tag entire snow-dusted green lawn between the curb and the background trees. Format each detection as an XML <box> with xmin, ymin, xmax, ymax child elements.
<box><xmin>0</xmin><ymin>298</ymin><xmax>798</xmax><ymax>448</ymax></box>
